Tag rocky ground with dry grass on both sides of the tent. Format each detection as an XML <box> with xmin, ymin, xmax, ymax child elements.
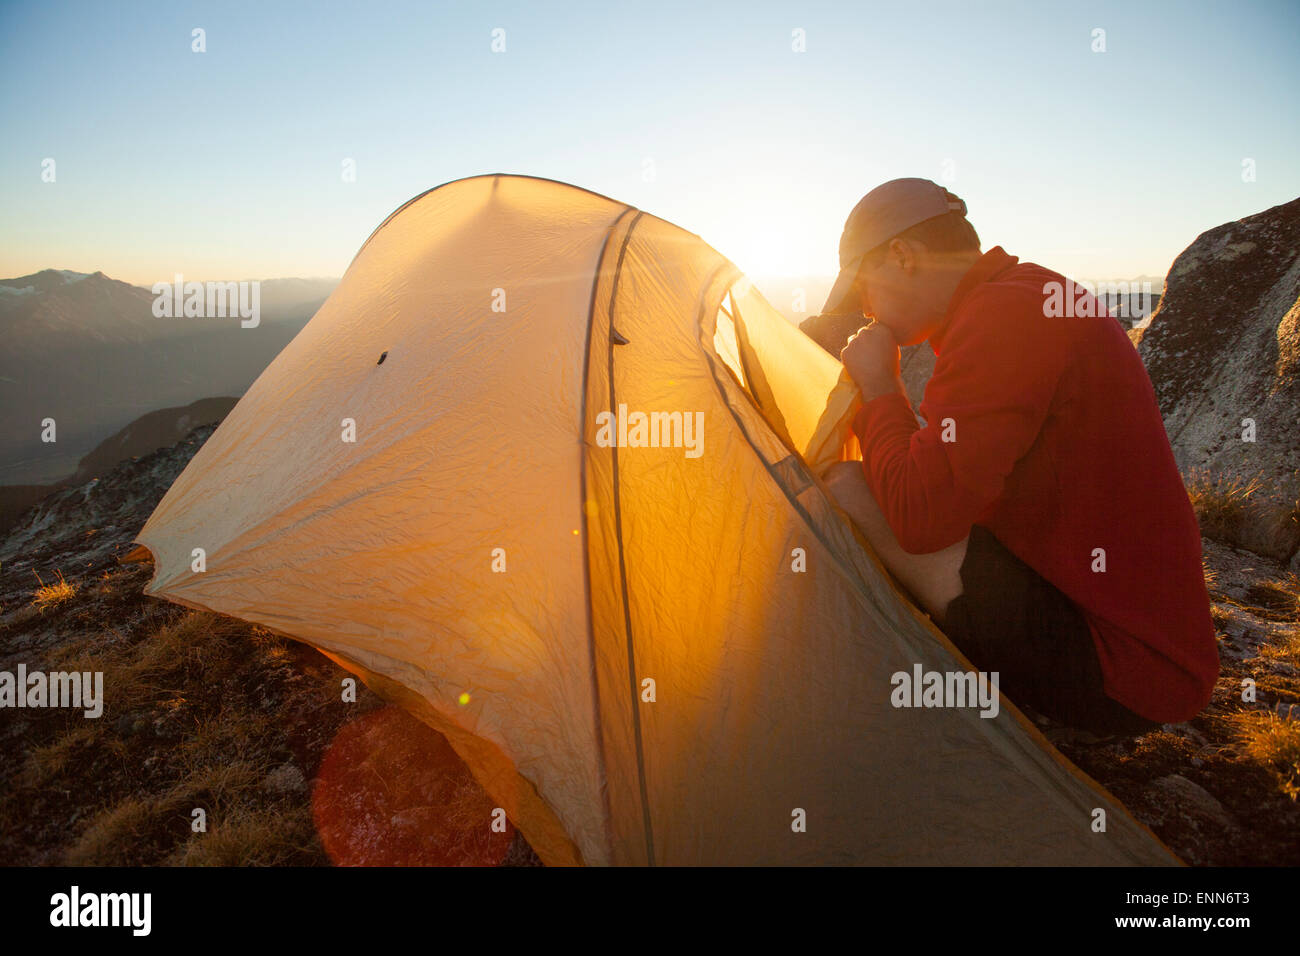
<box><xmin>0</xmin><ymin>427</ymin><xmax>1300</xmax><ymax>865</ymax></box>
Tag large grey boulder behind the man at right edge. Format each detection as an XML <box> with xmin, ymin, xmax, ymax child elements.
<box><xmin>1138</xmin><ymin>199</ymin><xmax>1300</xmax><ymax>558</ymax></box>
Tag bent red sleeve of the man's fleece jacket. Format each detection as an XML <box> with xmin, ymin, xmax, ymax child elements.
<box><xmin>853</xmin><ymin>289</ymin><xmax>1070</xmax><ymax>554</ymax></box>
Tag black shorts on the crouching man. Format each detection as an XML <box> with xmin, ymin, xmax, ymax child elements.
<box><xmin>943</xmin><ymin>524</ymin><xmax>1160</xmax><ymax>736</ymax></box>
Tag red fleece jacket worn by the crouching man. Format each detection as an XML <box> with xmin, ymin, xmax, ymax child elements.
<box><xmin>853</xmin><ymin>246</ymin><xmax>1219</xmax><ymax>722</ymax></box>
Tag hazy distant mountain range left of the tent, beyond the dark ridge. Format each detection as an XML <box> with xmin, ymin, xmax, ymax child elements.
<box><xmin>0</xmin><ymin>269</ymin><xmax>338</xmax><ymax>485</ymax></box>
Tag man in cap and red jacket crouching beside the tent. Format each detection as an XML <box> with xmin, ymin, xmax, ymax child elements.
<box><xmin>824</xmin><ymin>179</ymin><xmax>1219</xmax><ymax>735</ymax></box>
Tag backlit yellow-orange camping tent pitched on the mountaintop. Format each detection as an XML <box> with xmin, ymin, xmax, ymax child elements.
<box><xmin>138</xmin><ymin>174</ymin><xmax>1178</xmax><ymax>865</ymax></box>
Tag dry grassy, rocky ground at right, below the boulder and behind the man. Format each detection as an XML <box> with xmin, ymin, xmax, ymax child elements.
<box><xmin>1040</xmin><ymin>538</ymin><xmax>1300</xmax><ymax>866</ymax></box>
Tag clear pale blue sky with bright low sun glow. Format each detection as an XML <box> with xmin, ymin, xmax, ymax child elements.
<box><xmin>0</xmin><ymin>0</ymin><xmax>1300</xmax><ymax>295</ymax></box>
